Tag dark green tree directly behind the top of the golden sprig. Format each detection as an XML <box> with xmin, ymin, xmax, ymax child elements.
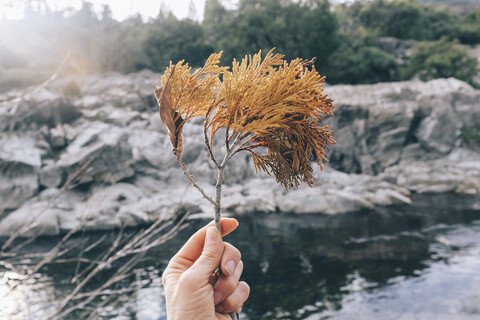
<box><xmin>204</xmin><ymin>0</ymin><xmax>339</xmax><ymax>70</ymax></box>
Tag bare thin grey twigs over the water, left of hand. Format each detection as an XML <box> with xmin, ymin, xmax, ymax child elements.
<box><xmin>0</xmin><ymin>153</ymin><xmax>189</xmax><ymax>320</ymax></box>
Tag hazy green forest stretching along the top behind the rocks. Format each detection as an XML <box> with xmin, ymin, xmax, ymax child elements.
<box><xmin>0</xmin><ymin>0</ymin><xmax>480</xmax><ymax>92</ymax></box>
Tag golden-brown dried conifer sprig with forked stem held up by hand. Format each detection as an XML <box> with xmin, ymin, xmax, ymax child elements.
<box><xmin>155</xmin><ymin>49</ymin><xmax>335</xmax><ymax>318</ymax></box>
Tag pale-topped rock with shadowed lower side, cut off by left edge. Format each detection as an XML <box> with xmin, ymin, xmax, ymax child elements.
<box><xmin>0</xmin><ymin>133</ymin><xmax>42</xmax><ymax>212</ymax></box>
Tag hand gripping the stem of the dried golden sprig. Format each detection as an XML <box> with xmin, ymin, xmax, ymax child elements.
<box><xmin>162</xmin><ymin>218</ymin><xmax>250</xmax><ymax>320</ymax></box>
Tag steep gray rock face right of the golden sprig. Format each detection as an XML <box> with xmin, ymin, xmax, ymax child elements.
<box><xmin>326</xmin><ymin>78</ymin><xmax>480</xmax><ymax>174</ymax></box>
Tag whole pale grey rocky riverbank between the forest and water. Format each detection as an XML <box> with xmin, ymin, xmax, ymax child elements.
<box><xmin>0</xmin><ymin>71</ymin><xmax>480</xmax><ymax>236</ymax></box>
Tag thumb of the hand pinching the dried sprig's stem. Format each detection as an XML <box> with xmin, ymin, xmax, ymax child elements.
<box><xmin>189</xmin><ymin>227</ymin><xmax>224</xmax><ymax>281</ymax></box>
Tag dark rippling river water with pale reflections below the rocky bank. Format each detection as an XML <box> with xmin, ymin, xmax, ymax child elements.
<box><xmin>0</xmin><ymin>196</ymin><xmax>480</xmax><ymax>320</ymax></box>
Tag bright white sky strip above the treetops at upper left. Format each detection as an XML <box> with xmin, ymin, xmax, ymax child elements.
<box><xmin>0</xmin><ymin>0</ymin><xmax>214</xmax><ymax>20</ymax></box>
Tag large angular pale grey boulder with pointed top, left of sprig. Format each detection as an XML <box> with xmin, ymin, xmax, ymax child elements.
<box><xmin>57</xmin><ymin>122</ymin><xmax>134</xmax><ymax>183</ymax></box>
